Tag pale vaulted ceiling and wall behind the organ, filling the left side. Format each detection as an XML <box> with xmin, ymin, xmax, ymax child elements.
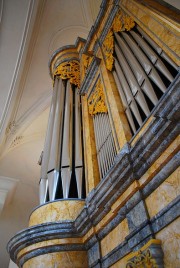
<box><xmin>0</xmin><ymin>0</ymin><xmax>101</xmax><ymax>268</ymax></box>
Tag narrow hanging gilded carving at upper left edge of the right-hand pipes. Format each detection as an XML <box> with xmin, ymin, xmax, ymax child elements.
<box><xmin>102</xmin><ymin>30</ymin><xmax>114</xmax><ymax>71</ymax></box>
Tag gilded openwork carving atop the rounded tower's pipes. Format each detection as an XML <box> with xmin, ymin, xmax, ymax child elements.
<box><xmin>54</xmin><ymin>60</ymin><xmax>80</xmax><ymax>88</ymax></box>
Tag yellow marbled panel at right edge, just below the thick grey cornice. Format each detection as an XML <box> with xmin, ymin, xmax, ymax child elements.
<box><xmin>145</xmin><ymin>169</ymin><xmax>180</xmax><ymax>218</ymax></box>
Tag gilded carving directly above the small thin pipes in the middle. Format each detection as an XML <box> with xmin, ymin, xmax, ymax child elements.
<box><xmin>88</xmin><ymin>80</ymin><xmax>108</xmax><ymax>116</ymax></box>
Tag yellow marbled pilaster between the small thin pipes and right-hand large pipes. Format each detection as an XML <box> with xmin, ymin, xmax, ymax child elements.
<box><xmin>100</xmin><ymin>55</ymin><xmax>131</xmax><ymax>150</ymax></box>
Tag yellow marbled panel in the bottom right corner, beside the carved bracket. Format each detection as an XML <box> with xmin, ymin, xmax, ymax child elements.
<box><xmin>156</xmin><ymin>219</ymin><xmax>180</xmax><ymax>268</ymax></box>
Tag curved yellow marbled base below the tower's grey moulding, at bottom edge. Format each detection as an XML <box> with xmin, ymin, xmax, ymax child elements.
<box><xmin>23</xmin><ymin>251</ymin><xmax>88</xmax><ymax>268</ymax></box>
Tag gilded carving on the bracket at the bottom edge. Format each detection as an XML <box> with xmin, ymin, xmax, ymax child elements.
<box><xmin>126</xmin><ymin>249</ymin><xmax>158</xmax><ymax>268</ymax></box>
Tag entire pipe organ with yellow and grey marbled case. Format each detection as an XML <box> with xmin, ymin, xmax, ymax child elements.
<box><xmin>8</xmin><ymin>0</ymin><xmax>180</xmax><ymax>268</ymax></box>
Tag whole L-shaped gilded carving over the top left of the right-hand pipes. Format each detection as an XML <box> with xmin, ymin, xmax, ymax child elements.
<box><xmin>102</xmin><ymin>11</ymin><xmax>135</xmax><ymax>71</ymax></box>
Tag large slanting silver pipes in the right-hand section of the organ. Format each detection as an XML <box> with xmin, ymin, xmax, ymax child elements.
<box><xmin>113</xmin><ymin>26</ymin><xmax>178</xmax><ymax>134</ymax></box>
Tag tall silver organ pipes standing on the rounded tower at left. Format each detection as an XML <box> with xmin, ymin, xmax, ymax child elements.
<box><xmin>40</xmin><ymin>77</ymin><xmax>83</xmax><ymax>204</ymax></box>
